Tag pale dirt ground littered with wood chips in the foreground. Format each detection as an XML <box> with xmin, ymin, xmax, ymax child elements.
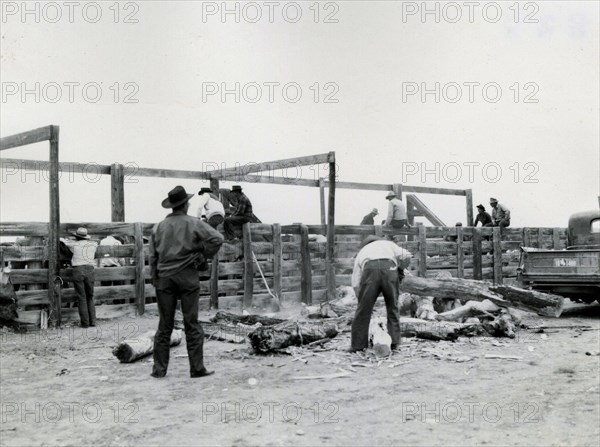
<box><xmin>0</xmin><ymin>304</ymin><xmax>600</xmax><ymax>446</ymax></box>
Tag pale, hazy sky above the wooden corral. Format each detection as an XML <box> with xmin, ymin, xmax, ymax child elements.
<box><xmin>0</xmin><ymin>1</ymin><xmax>600</xmax><ymax>231</ymax></box>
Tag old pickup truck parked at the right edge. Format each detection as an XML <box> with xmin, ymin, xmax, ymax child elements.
<box><xmin>517</xmin><ymin>210</ymin><xmax>600</xmax><ymax>303</ymax></box>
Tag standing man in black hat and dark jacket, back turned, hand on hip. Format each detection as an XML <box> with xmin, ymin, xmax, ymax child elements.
<box><xmin>149</xmin><ymin>186</ymin><xmax>223</xmax><ymax>378</ymax></box>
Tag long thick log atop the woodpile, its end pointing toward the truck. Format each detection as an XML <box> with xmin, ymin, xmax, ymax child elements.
<box><xmin>400</xmin><ymin>276</ymin><xmax>564</xmax><ymax>317</ymax></box>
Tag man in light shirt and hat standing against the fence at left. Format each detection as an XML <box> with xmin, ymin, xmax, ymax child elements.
<box><xmin>61</xmin><ymin>227</ymin><xmax>98</xmax><ymax>328</ymax></box>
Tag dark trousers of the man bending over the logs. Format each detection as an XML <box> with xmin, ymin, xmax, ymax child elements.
<box><xmin>351</xmin><ymin>259</ymin><xmax>402</xmax><ymax>350</ymax></box>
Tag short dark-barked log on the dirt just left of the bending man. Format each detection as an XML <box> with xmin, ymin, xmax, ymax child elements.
<box><xmin>248</xmin><ymin>320</ymin><xmax>338</xmax><ymax>354</ymax></box>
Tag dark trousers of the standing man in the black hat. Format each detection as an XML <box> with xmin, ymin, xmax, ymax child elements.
<box><xmin>152</xmin><ymin>266</ymin><xmax>204</xmax><ymax>376</ymax></box>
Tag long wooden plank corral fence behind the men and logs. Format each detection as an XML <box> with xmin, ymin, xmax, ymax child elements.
<box><xmin>0</xmin><ymin>222</ymin><xmax>567</xmax><ymax>325</ymax></box>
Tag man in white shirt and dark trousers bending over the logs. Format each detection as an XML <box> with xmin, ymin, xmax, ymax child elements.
<box><xmin>350</xmin><ymin>236</ymin><xmax>411</xmax><ymax>352</ymax></box>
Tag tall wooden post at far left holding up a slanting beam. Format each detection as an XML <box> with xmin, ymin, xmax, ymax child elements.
<box><xmin>48</xmin><ymin>126</ymin><xmax>62</xmax><ymax>326</ymax></box>
